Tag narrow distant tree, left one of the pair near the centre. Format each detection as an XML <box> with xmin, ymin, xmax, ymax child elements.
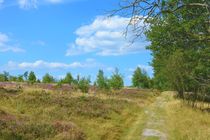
<box><xmin>95</xmin><ymin>70</ymin><xmax>109</xmax><ymax>90</ymax></box>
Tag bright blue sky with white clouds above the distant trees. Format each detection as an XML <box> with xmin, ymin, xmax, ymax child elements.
<box><xmin>0</xmin><ymin>0</ymin><xmax>153</xmax><ymax>85</ymax></box>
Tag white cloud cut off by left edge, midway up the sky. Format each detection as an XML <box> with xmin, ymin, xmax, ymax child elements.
<box><xmin>0</xmin><ymin>32</ymin><xmax>25</xmax><ymax>52</ymax></box>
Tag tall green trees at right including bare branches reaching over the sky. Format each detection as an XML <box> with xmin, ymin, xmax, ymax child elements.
<box><xmin>115</xmin><ymin>0</ymin><xmax>210</xmax><ymax>106</ymax></box>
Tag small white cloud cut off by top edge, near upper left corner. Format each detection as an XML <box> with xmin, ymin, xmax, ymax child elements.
<box><xmin>18</xmin><ymin>0</ymin><xmax>38</xmax><ymax>9</ymax></box>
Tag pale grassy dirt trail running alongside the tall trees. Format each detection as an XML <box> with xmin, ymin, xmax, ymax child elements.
<box><xmin>142</xmin><ymin>93</ymin><xmax>167</xmax><ymax>140</ymax></box>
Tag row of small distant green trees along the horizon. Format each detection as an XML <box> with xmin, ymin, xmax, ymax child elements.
<box><xmin>0</xmin><ymin>67</ymin><xmax>153</xmax><ymax>92</ymax></box>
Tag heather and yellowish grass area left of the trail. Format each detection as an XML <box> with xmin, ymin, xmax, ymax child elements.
<box><xmin>0</xmin><ymin>87</ymin><xmax>155</xmax><ymax>140</ymax></box>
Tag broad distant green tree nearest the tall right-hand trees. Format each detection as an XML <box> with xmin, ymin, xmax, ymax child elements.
<box><xmin>132</xmin><ymin>67</ymin><xmax>151</xmax><ymax>88</ymax></box>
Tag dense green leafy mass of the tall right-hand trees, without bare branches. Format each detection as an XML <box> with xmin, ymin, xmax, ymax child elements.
<box><xmin>146</xmin><ymin>0</ymin><xmax>210</xmax><ymax>97</ymax></box>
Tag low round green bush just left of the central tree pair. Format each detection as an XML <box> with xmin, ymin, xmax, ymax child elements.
<box><xmin>78</xmin><ymin>77</ymin><xmax>91</xmax><ymax>93</ymax></box>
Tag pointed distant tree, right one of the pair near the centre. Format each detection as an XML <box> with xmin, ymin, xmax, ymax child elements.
<box><xmin>109</xmin><ymin>68</ymin><xmax>124</xmax><ymax>90</ymax></box>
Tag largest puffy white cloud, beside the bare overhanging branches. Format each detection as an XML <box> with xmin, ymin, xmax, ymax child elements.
<box><xmin>66</xmin><ymin>16</ymin><xmax>149</xmax><ymax>56</ymax></box>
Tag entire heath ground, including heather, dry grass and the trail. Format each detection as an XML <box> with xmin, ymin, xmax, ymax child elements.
<box><xmin>0</xmin><ymin>83</ymin><xmax>210</xmax><ymax>140</ymax></box>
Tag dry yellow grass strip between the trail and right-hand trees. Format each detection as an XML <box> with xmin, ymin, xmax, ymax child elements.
<box><xmin>165</xmin><ymin>91</ymin><xmax>210</xmax><ymax>140</ymax></box>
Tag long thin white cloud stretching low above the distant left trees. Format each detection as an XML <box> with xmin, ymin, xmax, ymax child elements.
<box><xmin>7</xmin><ymin>59</ymin><xmax>99</xmax><ymax>69</ymax></box>
